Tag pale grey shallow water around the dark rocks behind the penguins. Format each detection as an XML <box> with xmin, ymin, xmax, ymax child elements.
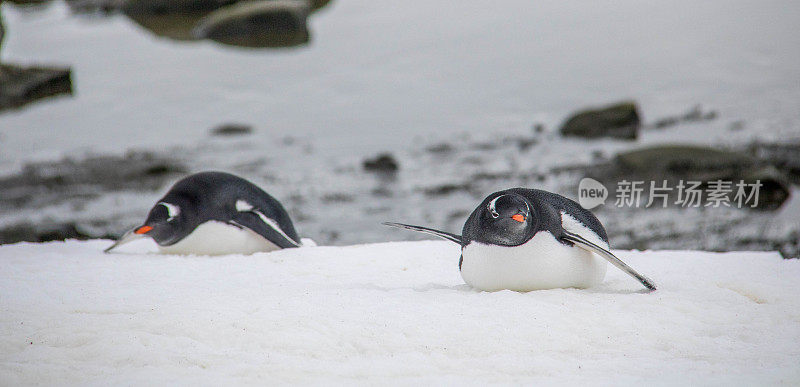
<box><xmin>0</xmin><ymin>0</ymin><xmax>800</xmax><ymax>255</ymax></box>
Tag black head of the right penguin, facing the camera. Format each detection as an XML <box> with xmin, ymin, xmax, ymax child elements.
<box><xmin>478</xmin><ymin>193</ymin><xmax>536</xmax><ymax>246</ymax></box>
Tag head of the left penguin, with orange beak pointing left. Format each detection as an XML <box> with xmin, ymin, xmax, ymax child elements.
<box><xmin>133</xmin><ymin>201</ymin><xmax>191</xmax><ymax>246</ymax></box>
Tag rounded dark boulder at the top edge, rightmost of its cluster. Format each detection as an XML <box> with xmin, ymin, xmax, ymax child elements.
<box><xmin>194</xmin><ymin>0</ymin><xmax>310</xmax><ymax>47</ymax></box>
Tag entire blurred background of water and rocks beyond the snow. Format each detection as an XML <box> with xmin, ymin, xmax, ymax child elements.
<box><xmin>0</xmin><ymin>0</ymin><xmax>800</xmax><ymax>258</ymax></box>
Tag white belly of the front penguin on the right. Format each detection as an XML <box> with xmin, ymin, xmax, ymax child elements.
<box><xmin>461</xmin><ymin>231</ymin><xmax>606</xmax><ymax>292</ymax></box>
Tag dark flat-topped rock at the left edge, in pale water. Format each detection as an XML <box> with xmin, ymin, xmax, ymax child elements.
<box><xmin>0</xmin><ymin>64</ymin><xmax>72</xmax><ymax>111</ymax></box>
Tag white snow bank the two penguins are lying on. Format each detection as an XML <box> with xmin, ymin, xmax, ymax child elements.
<box><xmin>0</xmin><ymin>240</ymin><xmax>800</xmax><ymax>386</ymax></box>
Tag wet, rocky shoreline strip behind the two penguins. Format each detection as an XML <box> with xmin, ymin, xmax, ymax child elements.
<box><xmin>0</xmin><ymin>118</ymin><xmax>800</xmax><ymax>257</ymax></box>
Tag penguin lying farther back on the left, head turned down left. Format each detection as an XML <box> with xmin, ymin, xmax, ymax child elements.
<box><xmin>104</xmin><ymin>172</ymin><xmax>301</xmax><ymax>255</ymax></box>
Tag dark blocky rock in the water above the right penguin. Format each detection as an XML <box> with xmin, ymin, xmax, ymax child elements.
<box><xmin>561</xmin><ymin>101</ymin><xmax>640</xmax><ymax>140</ymax></box>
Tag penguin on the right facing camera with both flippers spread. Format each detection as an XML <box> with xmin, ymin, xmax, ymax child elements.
<box><xmin>384</xmin><ymin>188</ymin><xmax>656</xmax><ymax>292</ymax></box>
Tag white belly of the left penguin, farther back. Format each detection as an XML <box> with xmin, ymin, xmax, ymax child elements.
<box><xmin>158</xmin><ymin>221</ymin><xmax>279</xmax><ymax>255</ymax></box>
